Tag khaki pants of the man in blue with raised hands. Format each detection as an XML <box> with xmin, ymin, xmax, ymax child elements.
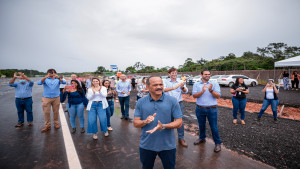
<box><xmin>42</xmin><ymin>96</ymin><xmax>60</xmax><ymax>126</ymax></box>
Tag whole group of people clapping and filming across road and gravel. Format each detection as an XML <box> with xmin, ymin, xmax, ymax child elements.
<box><xmin>9</xmin><ymin>68</ymin><xmax>290</xmax><ymax>168</ymax></box>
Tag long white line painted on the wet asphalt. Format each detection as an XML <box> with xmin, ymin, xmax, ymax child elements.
<box><xmin>59</xmin><ymin>104</ymin><xmax>81</xmax><ymax>169</ymax></box>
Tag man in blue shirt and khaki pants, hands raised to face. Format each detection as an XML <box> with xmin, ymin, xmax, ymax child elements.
<box><xmin>38</xmin><ymin>69</ymin><xmax>66</xmax><ymax>133</ymax></box>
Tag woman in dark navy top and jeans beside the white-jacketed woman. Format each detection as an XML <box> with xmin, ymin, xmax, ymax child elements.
<box><xmin>60</xmin><ymin>80</ymin><xmax>87</xmax><ymax>134</ymax></box>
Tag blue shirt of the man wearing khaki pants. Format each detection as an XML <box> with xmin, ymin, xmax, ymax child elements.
<box><xmin>38</xmin><ymin>77</ymin><xmax>66</xmax><ymax>98</ymax></box>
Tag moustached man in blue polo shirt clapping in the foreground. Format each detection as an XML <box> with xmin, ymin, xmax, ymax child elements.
<box><xmin>133</xmin><ymin>77</ymin><xmax>182</xmax><ymax>169</ymax></box>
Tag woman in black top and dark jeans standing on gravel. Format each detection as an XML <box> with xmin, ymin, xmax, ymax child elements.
<box><xmin>230</xmin><ymin>77</ymin><xmax>249</xmax><ymax>125</ymax></box>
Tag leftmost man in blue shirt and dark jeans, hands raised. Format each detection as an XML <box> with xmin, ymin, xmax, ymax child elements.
<box><xmin>9</xmin><ymin>72</ymin><xmax>34</xmax><ymax>127</ymax></box>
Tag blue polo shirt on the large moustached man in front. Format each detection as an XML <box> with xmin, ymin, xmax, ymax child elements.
<box><xmin>134</xmin><ymin>94</ymin><xmax>182</xmax><ymax>152</ymax></box>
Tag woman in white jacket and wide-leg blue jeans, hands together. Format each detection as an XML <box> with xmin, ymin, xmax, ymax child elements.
<box><xmin>86</xmin><ymin>78</ymin><xmax>108</xmax><ymax>140</ymax></box>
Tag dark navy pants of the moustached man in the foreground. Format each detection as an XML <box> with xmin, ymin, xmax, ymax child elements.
<box><xmin>140</xmin><ymin>147</ymin><xmax>176</xmax><ymax>169</ymax></box>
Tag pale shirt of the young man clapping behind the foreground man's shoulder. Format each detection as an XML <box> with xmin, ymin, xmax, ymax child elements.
<box><xmin>164</xmin><ymin>79</ymin><xmax>188</xmax><ymax>102</ymax></box>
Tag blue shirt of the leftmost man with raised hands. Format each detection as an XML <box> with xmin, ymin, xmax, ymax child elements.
<box><xmin>9</xmin><ymin>81</ymin><xmax>34</xmax><ymax>99</ymax></box>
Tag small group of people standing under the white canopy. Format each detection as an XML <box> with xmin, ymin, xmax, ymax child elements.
<box><xmin>282</xmin><ymin>71</ymin><xmax>300</xmax><ymax>90</ymax></box>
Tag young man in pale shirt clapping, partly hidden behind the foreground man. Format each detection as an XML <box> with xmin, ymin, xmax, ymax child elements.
<box><xmin>164</xmin><ymin>67</ymin><xmax>188</xmax><ymax>147</ymax></box>
